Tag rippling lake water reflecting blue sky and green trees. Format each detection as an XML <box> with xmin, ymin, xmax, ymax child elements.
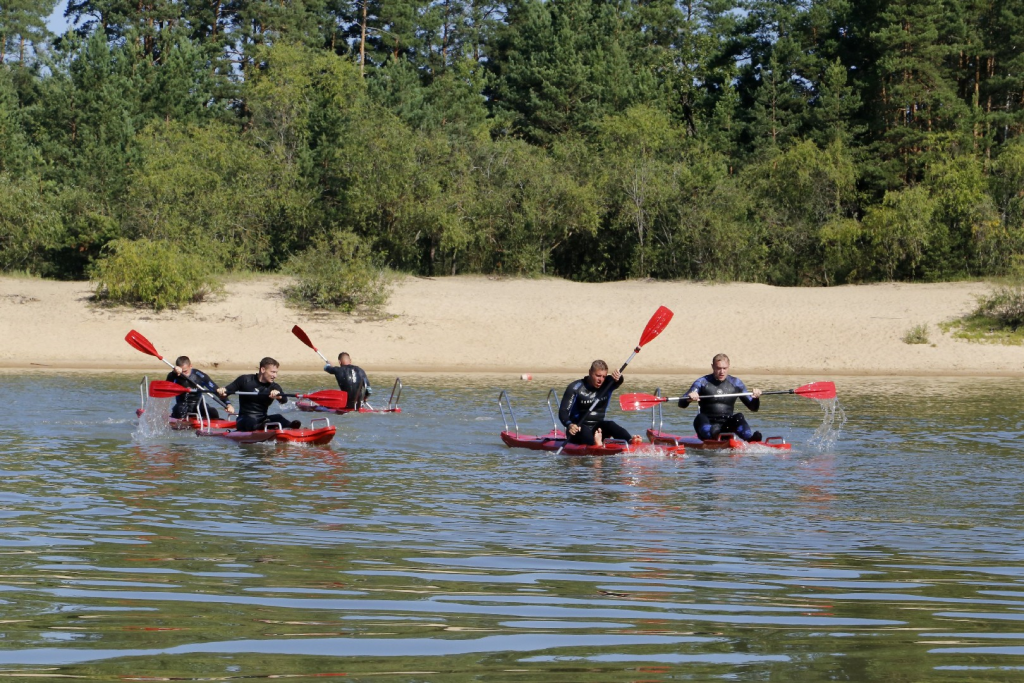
<box><xmin>0</xmin><ymin>373</ymin><xmax>1024</xmax><ymax>682</ymax></box>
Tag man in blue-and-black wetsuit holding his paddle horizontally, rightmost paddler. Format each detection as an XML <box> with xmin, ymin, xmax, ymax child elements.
<box><xmin>679</xmin><ymin>353</ymin><xmax>761</xmax><ymax>441</ymax></box>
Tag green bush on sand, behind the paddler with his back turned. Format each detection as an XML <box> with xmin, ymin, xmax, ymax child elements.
<box><xmin>285</xmin><ymin>232</ymin><xmax>391</xmax><ymax>312</ymax></box>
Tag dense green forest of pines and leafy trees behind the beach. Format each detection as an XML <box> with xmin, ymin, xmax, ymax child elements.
<box><xmin>0</xmin><ymin>0</ymin><xmax>1024</xmax><ymax>285</ymax></box>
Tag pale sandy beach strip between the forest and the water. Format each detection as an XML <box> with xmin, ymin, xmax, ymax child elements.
<box><xmin>0</xmin><ymin>276</ymin><xmax>1024</xmax><ymax>377</ymax></box>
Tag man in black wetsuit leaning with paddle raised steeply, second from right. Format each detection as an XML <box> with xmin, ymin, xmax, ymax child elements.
<box><xmin>558</xmin><ymin>360</ymin><xmax>640</xmax><ymax>445</ymax></box>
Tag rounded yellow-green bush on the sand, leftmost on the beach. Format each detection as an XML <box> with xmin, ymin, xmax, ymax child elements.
<box><xmin>91</xmin><ymin>240</ymin><xmax>216</xmax><ymax>310</ymax></box>
